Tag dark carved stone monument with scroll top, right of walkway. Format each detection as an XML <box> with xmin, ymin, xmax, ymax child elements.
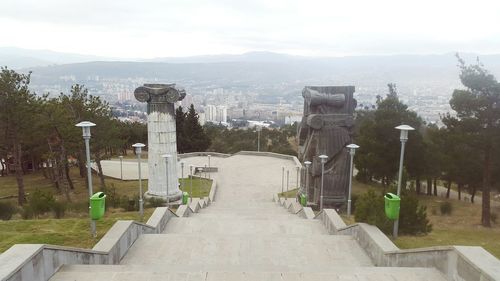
<box><xmin>297</xmin><ymin>86</ymin><xmax>356</xmax><ymax>207</ymax></box>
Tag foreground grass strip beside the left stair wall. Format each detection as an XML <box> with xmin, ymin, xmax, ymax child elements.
<box><xmin>0</xmin><ymin>209</ymin><xmax>153</xmax><ymax>252</ymax></box>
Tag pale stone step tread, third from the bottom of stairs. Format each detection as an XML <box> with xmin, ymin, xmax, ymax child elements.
<box><xmin>163</xmin><ymin>214</ymin><xmax>328</xmax><ymax>233</ymax></box>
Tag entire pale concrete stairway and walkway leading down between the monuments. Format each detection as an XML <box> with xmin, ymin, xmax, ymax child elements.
<box><xmin>51</xmin><ymin>155</ymin><xmax>445</xmax><ymax>281</ymax></box>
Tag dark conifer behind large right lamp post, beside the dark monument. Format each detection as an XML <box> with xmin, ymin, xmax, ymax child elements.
<box><xmin>355</xmin><ymin>84</ymin><xmax>424</xmax><ymax>186</ymax></box>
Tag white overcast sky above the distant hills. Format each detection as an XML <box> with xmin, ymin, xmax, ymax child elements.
<box><xmin>0</xmin><ymin>0</ymin><xmax>500</xmax><ymax>58</ymax></box>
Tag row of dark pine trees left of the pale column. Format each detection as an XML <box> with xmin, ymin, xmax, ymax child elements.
<box><xmin>0</xmin><ymin>67</ymin><xmax>147</xmax><ymax>205</ymax></box>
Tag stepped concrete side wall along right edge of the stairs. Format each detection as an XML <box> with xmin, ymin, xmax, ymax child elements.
<box><xmin>316</xmin><ymin>209</ymin><xmax>500</xmax><ymax>281</ymax></box>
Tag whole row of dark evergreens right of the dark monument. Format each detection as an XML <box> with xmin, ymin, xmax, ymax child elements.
<box><xmin>355</xmin><ymin>56</ymin><xmax>500</xmax><ymax>226</ymax></box>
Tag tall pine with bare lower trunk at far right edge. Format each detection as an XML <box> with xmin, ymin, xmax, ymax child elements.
<box><xmin>445</xmin><ymin>55</ymin><xmax>500</xmax><ymax>227</ymax></box>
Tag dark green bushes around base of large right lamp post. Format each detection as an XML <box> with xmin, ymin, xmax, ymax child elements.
<box><xmin>354</xmin><ymin>190</ymin><xmax>432</xmax><ymax>234</ymax></box>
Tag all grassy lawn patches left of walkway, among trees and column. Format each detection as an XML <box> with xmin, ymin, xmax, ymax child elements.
<box><xmin>0</xmin><ymin>169</ymin><xmax>211</xmax><ymax>252</ymax></box>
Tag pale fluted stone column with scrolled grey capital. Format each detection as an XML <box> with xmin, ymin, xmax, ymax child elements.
<box><xmin>134</xmin><ymin>84</ymin><xmax>186</xmax><ymax>201</ymax></box>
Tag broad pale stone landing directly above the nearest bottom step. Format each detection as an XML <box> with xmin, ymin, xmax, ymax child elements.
<box><xmin>121</xmin><ymin>233</ymin><xmax>372</xmax><ymax>266</ymax></box>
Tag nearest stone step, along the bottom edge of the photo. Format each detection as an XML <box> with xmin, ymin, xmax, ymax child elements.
<box><xmin>50</xmin><ymin>265</ymin><xmax>446</xmax><ymax>281</ymax></box>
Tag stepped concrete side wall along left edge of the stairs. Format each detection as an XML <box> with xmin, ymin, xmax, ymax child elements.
<box><xmin>0</xmin><ymin>207</ymin><xmax>176</xmax><ymax>281</ymax></box>
